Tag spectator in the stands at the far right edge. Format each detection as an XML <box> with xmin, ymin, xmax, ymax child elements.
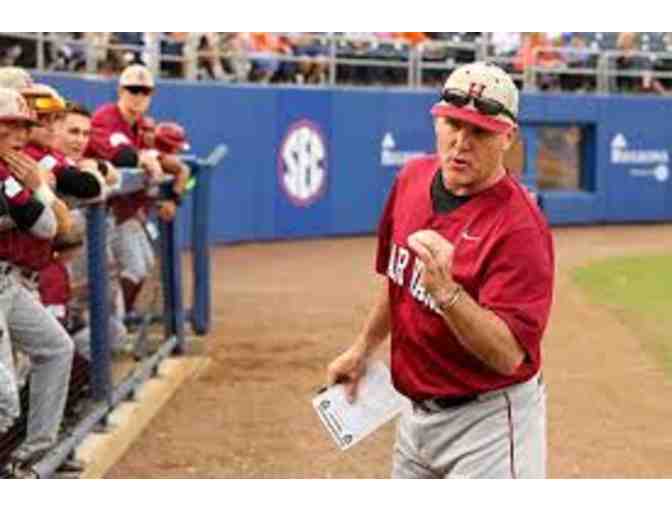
<box><xmin>615</xmin><ymin>32</ymin><xmax>666</xmax><ymax>94</ymax></box>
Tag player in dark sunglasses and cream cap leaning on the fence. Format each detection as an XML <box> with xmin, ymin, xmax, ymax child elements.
<box><xmin>85</xmin><ymin>64</ymin><xmax>163</xmax><ymax>313</ymax></box>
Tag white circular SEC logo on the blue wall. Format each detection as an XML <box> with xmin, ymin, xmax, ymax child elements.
<box><xmin>278</xmin><ymin>120</ymin><xmax>327</xmax><ymax>207</ymax></box>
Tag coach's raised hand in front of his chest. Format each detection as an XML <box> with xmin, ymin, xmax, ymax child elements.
<box><xmin>408</xmin><ymin>230</ymin><xmax>456</xmax><ymax>303</ymax></box>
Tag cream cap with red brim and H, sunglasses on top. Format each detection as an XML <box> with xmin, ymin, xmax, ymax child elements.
<box><xmin>431</xmin><ymin>62</ymin><xmax>518</xmax><ymax>133</ymax></box>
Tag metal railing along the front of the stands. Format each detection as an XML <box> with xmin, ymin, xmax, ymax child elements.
<box><xmin>0</xmin><ymin>32</ymin><xmax>672</xmax><ymax>93</ymax></box>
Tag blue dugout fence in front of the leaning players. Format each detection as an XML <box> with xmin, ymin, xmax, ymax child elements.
<box><xmin>0</xmin><ymin>157</ymin><xmax>215</xmax><ymax>478</ymax></box>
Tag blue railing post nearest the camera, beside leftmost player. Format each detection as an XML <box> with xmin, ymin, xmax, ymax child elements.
<box><xmin>86</xmin><ymin>204</ymin><xmax>112</xmax><ymax>403</ymax></box>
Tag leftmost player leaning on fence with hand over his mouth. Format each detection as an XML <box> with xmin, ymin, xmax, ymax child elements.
<box><xmin>0</xmin><ymin>89</ymin><xmax>74</xmax><ymax>477</ymax></box>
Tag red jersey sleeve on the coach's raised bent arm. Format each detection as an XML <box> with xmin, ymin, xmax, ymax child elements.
<box><xmin>478</xmin><ymin>227</ymin><xmax>554</xmax><ymax>363</ymax></box>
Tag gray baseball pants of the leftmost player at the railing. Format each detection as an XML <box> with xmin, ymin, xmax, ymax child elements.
<box><xmin>0</xmin><ymin>275</ymin><xmax>74</xmax><ymax>460</ymax></box>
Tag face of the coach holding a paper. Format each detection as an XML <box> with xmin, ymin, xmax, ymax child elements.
<box><xmin>434</xmin><ymin>117</ymin><xmax>516</xmax><ymax>195</ymax></box>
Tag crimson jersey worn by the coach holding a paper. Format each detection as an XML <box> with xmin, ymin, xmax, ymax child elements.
<box><xmin>376</xmin><ymin>156</ymin><xmax>554</xmax><ymax>400</ymax></box>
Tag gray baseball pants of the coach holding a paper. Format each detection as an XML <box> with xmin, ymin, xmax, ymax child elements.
<box><xmin>392</xmin><ymin>370</ymin><xmax>546</xmax><ymax>478</ymax></box>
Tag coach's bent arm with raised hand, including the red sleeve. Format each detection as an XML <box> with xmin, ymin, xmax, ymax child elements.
<box><xmin>409</xmin><ymin>228</ymin><xmax>553</xmax><ymax>375</ymax></box>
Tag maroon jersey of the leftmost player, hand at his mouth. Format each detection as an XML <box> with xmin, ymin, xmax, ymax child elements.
<box><xmin>0</xmin><ymin>161</ymin><xmax>51</xmax><ymax>270</ymax></box>
